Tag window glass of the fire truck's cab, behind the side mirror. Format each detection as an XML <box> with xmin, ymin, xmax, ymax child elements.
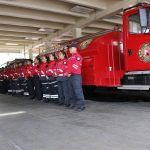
<box><xmin>129</xmin><ymin>10</ymin><xmax>150</xmax><ymax>34</ymax></box>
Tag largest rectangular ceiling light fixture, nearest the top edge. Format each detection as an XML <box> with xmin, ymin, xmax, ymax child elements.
<box><xmin>71</xmin><ymin>5</ymin><xmax>94</xmax><ymax>14</ymax></box>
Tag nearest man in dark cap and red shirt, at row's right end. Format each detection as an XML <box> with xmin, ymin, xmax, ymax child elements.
<box><xmin>68</xmin><ymin>44</ymin><xmax>85</xmax><ymax>111</ymax></box>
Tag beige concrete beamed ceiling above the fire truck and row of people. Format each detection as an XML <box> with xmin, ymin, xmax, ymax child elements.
<box><xmin>0</xmin><ymin>0</ymin><xmax>146</xmax><ymax>52</ymax></box>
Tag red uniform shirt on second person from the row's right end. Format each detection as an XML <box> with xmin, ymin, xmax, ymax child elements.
<box><xmin>55</xmin><ymin>59</ymin><xmax>68</xmax><ymax>77</ymax></box>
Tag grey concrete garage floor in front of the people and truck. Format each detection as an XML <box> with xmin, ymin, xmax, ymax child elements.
<box><xmin>0</xmin><ymin>95</ymin><xmax>150</xmax><ymax>150</ymax></box>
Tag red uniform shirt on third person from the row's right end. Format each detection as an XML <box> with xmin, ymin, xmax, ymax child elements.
<box><xmin>46</xmin><ymin>61</ymin><xmax>56</xmax><ymax>77</ymax></box>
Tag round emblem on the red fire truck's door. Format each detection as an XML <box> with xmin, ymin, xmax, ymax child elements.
<box><xmin>138</xmin><ymin>43</ymin><xmax>150</xmax><ymax>62</ymax></box>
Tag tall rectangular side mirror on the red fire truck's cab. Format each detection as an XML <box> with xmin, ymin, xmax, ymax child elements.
<box><xmin>139</xmin><ymin>8</ymin><xmax>148</xmax><ymax>28</ymax></box>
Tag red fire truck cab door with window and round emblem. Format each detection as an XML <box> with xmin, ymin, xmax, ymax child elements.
<box><xmin>124</xmin><ymin>10</ymin><xmax>150</xmax><ymax>71</ymax></box>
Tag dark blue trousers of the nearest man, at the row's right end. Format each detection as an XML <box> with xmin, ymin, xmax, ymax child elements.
<box><xmin>68</xmin><ymin>74</ymin><xmax>85</xmax><ymax>108</ymax></box>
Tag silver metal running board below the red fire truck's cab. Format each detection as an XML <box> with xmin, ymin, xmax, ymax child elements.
<box><xmin>117</xmin><ymin>85</ymin><xmax>150</xmax><ymax>90</ymax></box>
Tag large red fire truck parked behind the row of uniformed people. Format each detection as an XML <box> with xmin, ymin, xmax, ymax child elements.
<box><xmin>59</xmin><ymin>4</ymin><xmax>150</xmax><ymax>91</ymax></box>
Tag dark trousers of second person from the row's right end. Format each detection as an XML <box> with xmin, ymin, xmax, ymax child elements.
<box><xmin>57</xmin><ymin>77</ymin><xmax>70</xmax><ymax>105</ymax></box>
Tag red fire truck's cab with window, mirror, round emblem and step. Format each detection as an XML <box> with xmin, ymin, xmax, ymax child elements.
<box><xmin>119</xmin><ymin>4</ymin><xmax>150</xmax><ymax>90</ymax></box>
